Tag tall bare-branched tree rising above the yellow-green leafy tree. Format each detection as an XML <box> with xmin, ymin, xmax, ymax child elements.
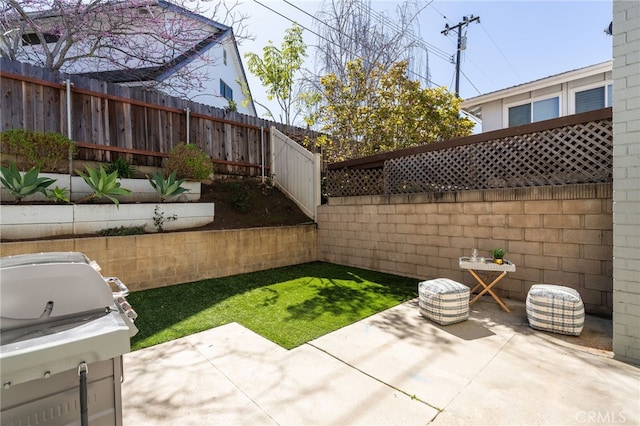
<box><xmin>316</xmin><ymin>0</ymin><xmax>429</xmax><ymax>85</ymax></box>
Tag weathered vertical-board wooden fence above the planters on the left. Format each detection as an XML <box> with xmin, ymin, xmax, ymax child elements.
<box><xmin>0</xmin><ymin>59</ymin><xmax>316</xmax><ymax>176</ymax></box>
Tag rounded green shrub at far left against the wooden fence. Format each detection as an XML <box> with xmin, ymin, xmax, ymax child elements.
<box><xmin>0</xmin><ymin>129</ymin><xmax>78</xmax><ymax>172</ymax></box>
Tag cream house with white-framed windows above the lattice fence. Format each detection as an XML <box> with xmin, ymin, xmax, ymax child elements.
<box><xmin>461</xmin><ymin>61</ymin><xmax>613</xmax><ymax>132</ymax></box>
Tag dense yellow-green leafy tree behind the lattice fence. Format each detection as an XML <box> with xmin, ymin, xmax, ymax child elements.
<box><xmin>320</xmin><ymin>60</ymin><xmax>473</xmax><ymax>162</ymax></box>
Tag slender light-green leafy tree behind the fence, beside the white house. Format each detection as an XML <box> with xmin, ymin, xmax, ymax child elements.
<box><xmin>244</xmin><ymin>23</ymin><xmax>307</xmax><ymax>126</ymax></box>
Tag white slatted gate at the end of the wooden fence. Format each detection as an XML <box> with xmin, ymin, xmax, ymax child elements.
<box><xmin>270</xmin><ymin>127</ymin><xmax>320</xmax><ymax>221</ymax></box>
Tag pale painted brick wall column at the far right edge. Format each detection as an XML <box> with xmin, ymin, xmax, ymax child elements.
<box><xmin>613</xmin><ymin>0</ymin><xmax>640</xmax><ymax>364</ymax></box>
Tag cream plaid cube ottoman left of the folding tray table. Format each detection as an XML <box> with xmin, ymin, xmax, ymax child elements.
<box><xmin>418</xmin><ymin>278</ymin><xmax>469</xmax><ymax>325</ymax></box>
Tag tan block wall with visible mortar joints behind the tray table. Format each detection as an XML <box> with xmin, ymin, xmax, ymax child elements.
<box><xmin>318</xmin><ymin>184</ymin><xmax>613</xmax><ymax>316</ymax></box>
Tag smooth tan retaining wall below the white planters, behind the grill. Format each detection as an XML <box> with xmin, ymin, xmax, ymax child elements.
<box><xmin>0</xmin><ymin>225</ymin><xmax>318</xmax><ymax>291</ymax></box>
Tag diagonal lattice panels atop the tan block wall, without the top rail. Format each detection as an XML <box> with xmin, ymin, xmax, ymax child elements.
<box><xmin>331</xmin><ymin>119</ymin><xmax>613</xmax><ymax>196</ymax></box>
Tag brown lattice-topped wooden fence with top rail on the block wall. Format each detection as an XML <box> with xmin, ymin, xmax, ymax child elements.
<box><xmin>326</xmin><ymin>108</ymin><xmax>613</xmax><ymax>197</ymax></box>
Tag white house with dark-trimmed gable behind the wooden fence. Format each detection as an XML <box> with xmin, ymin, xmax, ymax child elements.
<box><xmin>10</xmin><ymin>0</ymin><xmax>257</xmax><ymax>116</ymax></box>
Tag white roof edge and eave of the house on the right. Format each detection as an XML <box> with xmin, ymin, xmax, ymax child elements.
<box><xmin>460</xmin><ymin>60</ymin><xmax>613</xmax><ymax>119</ymax></box>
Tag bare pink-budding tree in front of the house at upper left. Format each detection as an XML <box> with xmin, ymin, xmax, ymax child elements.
<box><xmin>0</xmin><ymin>0</ymin><xmax>248</xmax><ymax>99</ymax></box>
